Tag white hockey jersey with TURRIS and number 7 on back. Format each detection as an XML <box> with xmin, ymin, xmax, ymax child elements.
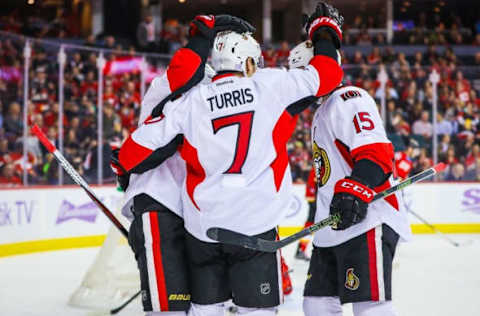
<box><xmin>119</xmin><ymin>57</ymin><xmax>342</xmax><ymax>242</ymax></box>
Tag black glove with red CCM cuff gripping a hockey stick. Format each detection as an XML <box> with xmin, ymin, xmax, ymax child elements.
<box><xmin>330</xmin><ymin>177</ymin><xmax>375</xmax><ymax>230</ymax></box>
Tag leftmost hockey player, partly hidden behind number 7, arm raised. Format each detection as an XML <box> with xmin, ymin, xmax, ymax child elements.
<box><xmin>112</xmin><ymin>15</ymin><xmax>254</xmax><ymax>316</ymax></box>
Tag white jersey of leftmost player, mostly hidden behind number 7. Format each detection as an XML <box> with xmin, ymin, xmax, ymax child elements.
<box><xmin>122</xmin><ymin>73</ymin><xmax>185</xmax><ymax>218</ymax></box>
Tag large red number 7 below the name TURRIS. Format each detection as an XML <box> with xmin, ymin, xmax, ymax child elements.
<box><xmin>212</xmin><ymin>111</ymin><xmax>254</xmax><ymax>174</ymax></box>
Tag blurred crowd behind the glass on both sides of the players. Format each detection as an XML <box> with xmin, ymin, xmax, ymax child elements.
<box><xmin>0</xmin><ymin>25</ymin><xmax>480</xmax><ymax>185</ymax></box>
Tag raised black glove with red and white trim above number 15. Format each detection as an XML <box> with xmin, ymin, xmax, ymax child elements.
<box><xmin>304</xmin><ymin>2</ymin><xmax>343</xmax><ymax>49</ymax></box>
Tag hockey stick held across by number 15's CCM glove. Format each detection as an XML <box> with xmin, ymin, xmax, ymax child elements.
<box><xmin>207</xmin><ymin>163</ymin><xmax>446</xmax><ymax>252</ymax></box>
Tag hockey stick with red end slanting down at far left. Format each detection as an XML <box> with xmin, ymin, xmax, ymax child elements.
<box><xmin>32</xmin><ymin>124</ymin><xmax>141</xmax><ymax>315</ymax></box>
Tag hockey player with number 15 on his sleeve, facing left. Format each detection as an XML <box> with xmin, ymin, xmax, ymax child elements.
<box><xmin>290</xmin><ymin>39</ymin><xmax>410</xmax><ymax>316</ymax></box>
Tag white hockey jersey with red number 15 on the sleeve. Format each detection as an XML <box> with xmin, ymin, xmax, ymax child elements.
<box><xmin>312</xmin><ymin>86</ymin><xmax>411</xmax><ymax>247</ymax></box>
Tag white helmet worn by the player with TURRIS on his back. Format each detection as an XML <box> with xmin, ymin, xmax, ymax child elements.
<box><xmin>212</xmin><ymin>31</ymin><xmax>263</xmax><ymax>75</ymax></box>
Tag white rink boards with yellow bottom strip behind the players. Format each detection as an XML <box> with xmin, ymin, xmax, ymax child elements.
<box><xmin>0</xmin><ymin>183</ymin><xmax>480</xmax><ymax>257</ymax></box>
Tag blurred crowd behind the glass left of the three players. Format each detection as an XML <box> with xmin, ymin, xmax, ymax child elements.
<box><xmin>0</xmin><ymin>39</ymin><xmax>146</xmax><ymax>184</ymax></box>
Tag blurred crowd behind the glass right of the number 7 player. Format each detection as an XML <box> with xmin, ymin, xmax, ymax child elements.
<box><xmin>284</xmin><ymin>46</ymin><xmax>480</xmax><ymax>182</ymax></box>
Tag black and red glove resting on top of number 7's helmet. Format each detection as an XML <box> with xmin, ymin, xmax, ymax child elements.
<box><xmin>188</xmin><ymin>14</ymin><xmax>255</xmax><ymax>41</ymax></box>
